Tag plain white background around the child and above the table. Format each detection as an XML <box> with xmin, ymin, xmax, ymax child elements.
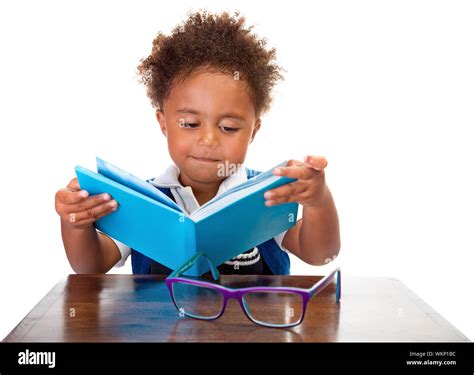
<box><xmin>0</xmin><ymin>0</ymin><xmax>474</xmax><ymax>340</ymax></box>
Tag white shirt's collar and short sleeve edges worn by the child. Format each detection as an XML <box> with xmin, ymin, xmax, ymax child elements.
<box><xmin>99</xmin><ymin>164</ymin><xmax>288</xmax><ymax>267</ymax></box>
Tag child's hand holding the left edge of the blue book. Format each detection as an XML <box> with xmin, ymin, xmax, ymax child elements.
<box><xmin>55</xmin><ymin>178</ymin><xmax>118</xmax><ymax>229</ymax></box>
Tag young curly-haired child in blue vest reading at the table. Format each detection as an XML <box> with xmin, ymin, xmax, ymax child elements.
<box><xmin>55</xmin><ymin>12</ymin><xmax>340</xmax><ymax>274</ymax></box>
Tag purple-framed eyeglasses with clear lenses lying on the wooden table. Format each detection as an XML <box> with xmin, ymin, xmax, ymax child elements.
<box><xmin>166</xmin><ymin>253</ymin><xmax>341</xmax><ymax>328</ymax></box>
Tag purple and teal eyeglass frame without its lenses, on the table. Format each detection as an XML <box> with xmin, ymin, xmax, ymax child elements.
<box><xmin>166</xmin><ymin>253</ymin><xmax>341</xmax><ymax>328</ymax></box>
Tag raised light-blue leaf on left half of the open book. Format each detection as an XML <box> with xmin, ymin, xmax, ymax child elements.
<box><xmin>96</xmin><ymin>157</ymin><xmax>184</xmax><ymax>213</ymax></box>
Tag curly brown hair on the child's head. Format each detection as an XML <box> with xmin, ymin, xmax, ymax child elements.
<box><xmin>138</xmin><ymin>11</ymin><xmax>283</xmax><ymax>115</ymax></box>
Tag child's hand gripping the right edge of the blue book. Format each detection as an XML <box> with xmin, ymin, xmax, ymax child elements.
<box><xmin>264</xmin><ymin>156</ymin><xmax>328</xmax><ymax>207</ymax></box>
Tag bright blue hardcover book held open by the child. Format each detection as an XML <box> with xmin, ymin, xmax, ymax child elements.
<box><xmin>75</xmin><ymin>158</ymin><xmax>298</xmax><ymax>276</ymax></box>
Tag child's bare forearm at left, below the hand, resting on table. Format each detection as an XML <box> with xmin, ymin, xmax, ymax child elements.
<box><xmin>61</xmin><ymin>220</ymin><xmax>121</xmax><ymax>274</ymax></box>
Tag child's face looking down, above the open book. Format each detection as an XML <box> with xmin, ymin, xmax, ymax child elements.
<box><xmin>157</xmin><ymin>70</ymin><xmax>260</xmax><ymax>189</ymax></box>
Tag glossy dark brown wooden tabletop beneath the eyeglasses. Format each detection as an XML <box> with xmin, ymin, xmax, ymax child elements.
<box><xmin>4</xmin><ymin>275</ymin><xmax>469</xmax><ymax>342</ymax></box>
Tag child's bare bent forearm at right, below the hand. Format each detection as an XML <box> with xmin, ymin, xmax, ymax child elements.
<box><xmin>282</xmin><ymin>185</ymin><xmax>341</xmax><ymax>266</ymax></box>
